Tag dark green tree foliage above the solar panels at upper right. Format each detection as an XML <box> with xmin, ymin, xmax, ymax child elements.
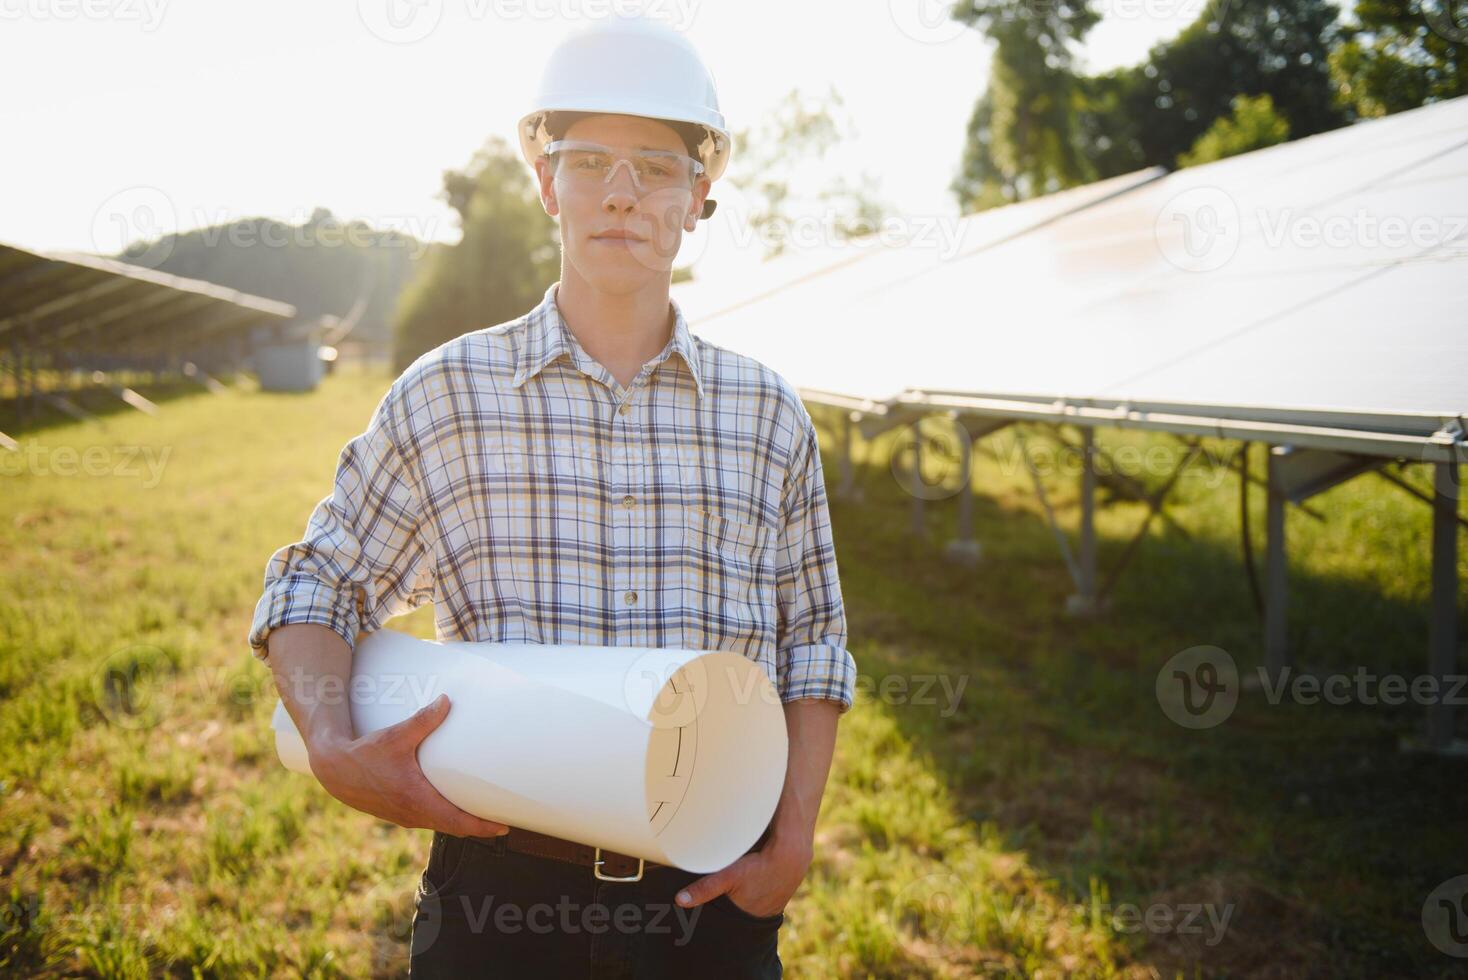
<box><xmin>951</xmin><ymin>0</ymin><xmax>1468</xmax><ymax>211</ymax></box>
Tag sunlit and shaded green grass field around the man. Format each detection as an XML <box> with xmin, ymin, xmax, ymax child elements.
<box><xmin>0</xmin><ymin>363</ymin><xmax>1468</xmax><ymax>977</ymax></box>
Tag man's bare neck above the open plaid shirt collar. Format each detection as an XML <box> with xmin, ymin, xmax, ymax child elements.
<box><xmin>555</xmin><ymin>266</ymin><xmax>674</xmax><ymax>387</ymax></box>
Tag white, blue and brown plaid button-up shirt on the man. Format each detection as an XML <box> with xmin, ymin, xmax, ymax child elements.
<box><xmin>250</xmin><ymin>283</ymin><xmax>856</xmax><ymax>713</ymax></box>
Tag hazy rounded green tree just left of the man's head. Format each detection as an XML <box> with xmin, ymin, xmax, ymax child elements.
<box><xmin>393</xmin><ymin>136</ymin><xmax>559</xmax><ymax>371</ymax></box>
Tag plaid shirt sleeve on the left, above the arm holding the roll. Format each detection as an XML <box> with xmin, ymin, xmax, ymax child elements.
<box><xmin>248</xmin><ymin>384</ymin><xmax>433</xmax><ymax>660</ymax></box>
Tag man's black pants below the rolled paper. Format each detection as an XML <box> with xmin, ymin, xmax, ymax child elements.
<box><xmin>411</xmin><ymin>833</ymin><xmax>785</xmax><ymax>980</ymax></box>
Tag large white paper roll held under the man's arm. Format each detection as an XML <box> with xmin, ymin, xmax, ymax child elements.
<box><xmin>272</xmin><ymin>629</ymin><xmax>788</xmax><ymax>873</ymax></box>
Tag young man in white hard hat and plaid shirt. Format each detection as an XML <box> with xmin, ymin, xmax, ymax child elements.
<box><xmin>250</xmin><ymin>19</ymin><xmax>856</xmax><ymax>977</ymax></box>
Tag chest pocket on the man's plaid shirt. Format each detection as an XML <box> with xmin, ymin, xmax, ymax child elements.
<box><xmin>680</xmin><ymin>508</ymin><xmax>775</xmax><ymax>659</ymax></box>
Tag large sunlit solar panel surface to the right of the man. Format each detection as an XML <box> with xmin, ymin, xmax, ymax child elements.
<box><xmin>674</xmin><ymin>98</ymin><xmax>1468</xmax><ymax>459</ymax></box>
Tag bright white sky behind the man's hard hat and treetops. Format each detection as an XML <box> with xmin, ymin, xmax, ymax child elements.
<box><xmin>0</xmin><ymin>0</ymin><xmax>1201</xmax><ymax>268</ymax></box>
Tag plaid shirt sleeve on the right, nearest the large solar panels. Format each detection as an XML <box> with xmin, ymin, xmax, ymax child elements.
<box><xmin>775</xmin><ymin>414</ymin><xmax>856</xmax><ymax>714</ymax></box>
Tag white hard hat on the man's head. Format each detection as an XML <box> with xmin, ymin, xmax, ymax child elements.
<box><xmin>518</xmin><ymin>16</ymin><xmax>730</xmax><ymax>208</ymax></box>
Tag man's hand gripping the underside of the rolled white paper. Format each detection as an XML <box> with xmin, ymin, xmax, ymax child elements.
<box><xmin>308</xmin><ymin>694</ymin><xmax>509</xmax><ymax>838</ymax></box>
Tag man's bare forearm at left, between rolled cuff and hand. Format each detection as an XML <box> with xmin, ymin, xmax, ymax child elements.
<box><xmin>266</xmin><ymin>622</ymin><xmax>357</xmax><ymax>751</ymax></box>
